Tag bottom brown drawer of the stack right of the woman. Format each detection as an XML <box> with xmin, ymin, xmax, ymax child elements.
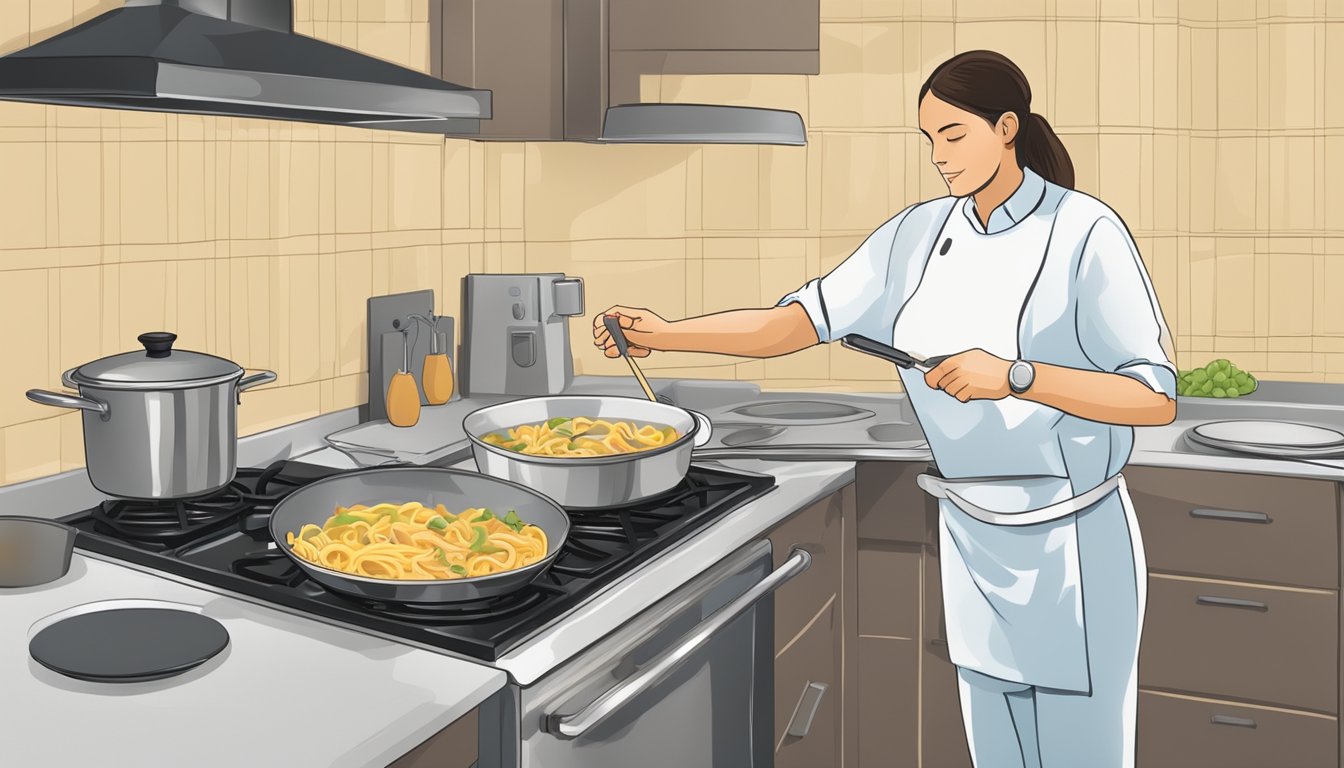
<box><xmin>1136</xmin><ymin>690</ymin><xmax>1339</xmax><ymax>768</ymax></box>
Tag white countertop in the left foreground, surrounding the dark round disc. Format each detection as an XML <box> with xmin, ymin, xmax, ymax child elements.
<box><xmin>0</xmin><ymin>553</ymin><xmax>505</xmax><ymax>768</ymax></box>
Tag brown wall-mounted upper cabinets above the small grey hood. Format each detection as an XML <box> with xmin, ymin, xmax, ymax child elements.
<box><xmin>430</xmin><ymin>0</ymin><xmax>821</xmax><ymax>141</ymax></box>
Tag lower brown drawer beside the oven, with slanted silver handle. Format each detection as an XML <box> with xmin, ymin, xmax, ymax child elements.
<box><xmin>774</xmin><ymin>603</ymin><xmax>840</xmax><ymax>768</ymax></box>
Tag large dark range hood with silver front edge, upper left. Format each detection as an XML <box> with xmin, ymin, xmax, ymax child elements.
<box><xmin>0</xmin><ymin>0</ymin><xmax>491</xmax><ymax>133</ymax></box>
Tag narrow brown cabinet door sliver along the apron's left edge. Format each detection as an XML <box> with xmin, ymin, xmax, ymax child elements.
<box><xmin>919</xmin><ymin>499</ymin><xmax>970</xmax><ymax>768</ymax></box>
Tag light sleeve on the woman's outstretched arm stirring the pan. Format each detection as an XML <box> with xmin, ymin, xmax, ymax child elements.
<box><xmin>775</xmin><ymin>208</ymin><xmax>910</xmax><ymax>342</ymax></box>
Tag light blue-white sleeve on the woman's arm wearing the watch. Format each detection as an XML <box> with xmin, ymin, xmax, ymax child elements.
<box><xmin>1075</xmin><ymin>217</ymin><xmax>1176</xmax><ymax>398</ymax></box>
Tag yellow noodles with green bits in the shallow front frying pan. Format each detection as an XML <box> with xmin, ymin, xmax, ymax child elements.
<box><xmin>286</xmin><ymin>502</ymin><xmax>547</xmax><ymax>580</ymax></box>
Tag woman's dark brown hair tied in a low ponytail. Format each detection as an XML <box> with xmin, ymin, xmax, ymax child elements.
<box><xmin>919</xmin><ymin>51</ymin><xmax>1074</xmax><ymax>190</ymax></box>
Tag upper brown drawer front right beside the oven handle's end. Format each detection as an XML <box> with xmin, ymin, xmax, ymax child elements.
<box><xmin>770</xmin><ymin>486</ymin><xmax>853</xmax><ymax>651</ymax></box>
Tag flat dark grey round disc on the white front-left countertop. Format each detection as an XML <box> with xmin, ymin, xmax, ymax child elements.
<box><xmin>28</xmin><ymin>608</ymin><xmax>228</xmax><ymax>683</ymax></box>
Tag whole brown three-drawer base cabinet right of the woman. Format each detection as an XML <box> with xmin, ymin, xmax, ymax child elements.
<box><xmin>1125</xmin><ymin>467</ymin><xmax>1341</xmax><ymax>768</ymax></box>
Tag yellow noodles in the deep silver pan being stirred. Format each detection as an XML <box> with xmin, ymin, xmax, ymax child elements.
<box><xmin>481</xmin><ymin>416</ymin><xmax>680</xmax><ymax>456</ymax></box>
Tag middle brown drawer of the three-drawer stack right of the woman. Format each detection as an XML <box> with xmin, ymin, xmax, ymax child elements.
<box><xmin>1138</xmin><ymin>577</ymin><xmax>1339</xmax><ymax>713</ymax></box>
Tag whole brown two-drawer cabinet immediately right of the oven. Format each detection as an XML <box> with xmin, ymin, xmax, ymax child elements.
<box><xmin>770</xmin><ymin>486</ymin><xmax>853</xmax><ymax>768</ymax></box>
